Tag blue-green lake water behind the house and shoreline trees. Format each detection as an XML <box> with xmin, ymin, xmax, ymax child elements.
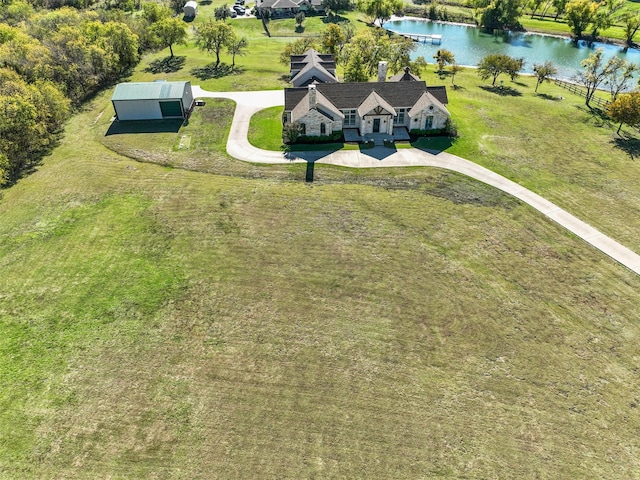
<box><xmin>384</xmin><ymin>19</ymin><xmax>640</xmax><ymax>79</ymax></box>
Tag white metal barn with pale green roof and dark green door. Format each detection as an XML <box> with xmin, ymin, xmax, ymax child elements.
<box><xmin>111</xmin><ymin>82</ymin><xmax>193</xmax><ymax>120</ymax></box>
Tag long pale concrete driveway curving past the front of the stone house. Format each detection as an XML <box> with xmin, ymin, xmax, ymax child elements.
<box><xmin>193</xmin><ymin>86</ymin><xmax>640</xmax><ymax>274</ymax></box>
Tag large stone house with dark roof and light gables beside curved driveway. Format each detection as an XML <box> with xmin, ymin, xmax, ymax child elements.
<box><xmin>283</xmin><ymin>64</ymin><xmax>450</xmax><ymax>141</ymax></box>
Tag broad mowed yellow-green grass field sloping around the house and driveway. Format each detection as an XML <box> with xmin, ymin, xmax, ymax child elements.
<box><xmin>0</xmin><ymin>8</ymin><xmax>640</xmax><ymax>480</ymax></box>
